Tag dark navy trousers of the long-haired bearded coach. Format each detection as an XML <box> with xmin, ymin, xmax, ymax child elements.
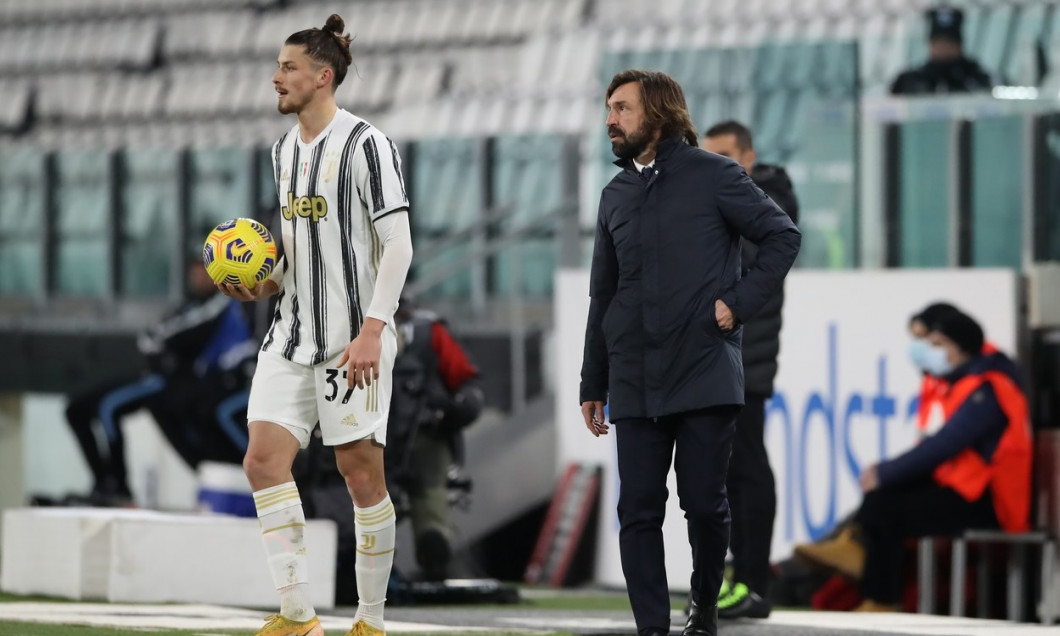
<box><xmin>615</xmin><ymin>406</ymin><xmax>740</xmax><ymax>634</ymax></box>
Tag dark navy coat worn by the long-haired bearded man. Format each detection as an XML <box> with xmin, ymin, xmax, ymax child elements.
<box><xmin>580</xmin><ymin>138</ymin><xmax>801</xmax><ymax>421</ymax></box>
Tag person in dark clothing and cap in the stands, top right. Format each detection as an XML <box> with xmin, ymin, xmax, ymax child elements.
<box><xmin>890</xmin><ymin>6</ymin><xmax>995</xmax><ymax>95</ymax></box>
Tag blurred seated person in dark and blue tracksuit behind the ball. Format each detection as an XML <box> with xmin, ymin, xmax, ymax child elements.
<box><xmin>66</xmin><ymin>259</ymin><xmax>258</xmax><ymax>506</ymax></box>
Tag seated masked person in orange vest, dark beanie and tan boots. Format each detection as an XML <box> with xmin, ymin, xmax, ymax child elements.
<box><xmin>796</xmin><ymin>311</ymin><xmax>1032</xmax><ymax>612</ymax></box>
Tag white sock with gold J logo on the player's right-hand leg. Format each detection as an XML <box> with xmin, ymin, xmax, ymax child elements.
<box><xmin>353</xmin><ymin>494</ymin><xmax>396</xmax><ymax>630</ymax></box>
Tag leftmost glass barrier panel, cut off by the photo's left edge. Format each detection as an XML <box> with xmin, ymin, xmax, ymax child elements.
<box><xmin>0</xmin><ymin>147</ymin><xmax>47</xmax><ymax>296</ymax></box>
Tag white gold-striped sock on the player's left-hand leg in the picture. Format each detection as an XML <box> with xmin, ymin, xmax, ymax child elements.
<box><xmin>254</xmin><ymin>481</ymin><xmax>317</xmax><ymax>621</ymax></box>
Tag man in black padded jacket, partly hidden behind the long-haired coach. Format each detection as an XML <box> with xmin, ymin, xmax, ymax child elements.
<box><xmin>702</xmin><ymin>120</ymin><xmax>798</xmax><ymax>618</ymax></box>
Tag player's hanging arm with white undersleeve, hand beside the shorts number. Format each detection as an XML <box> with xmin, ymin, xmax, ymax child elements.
<box><xmin>338</xmin><ymin>130</ymin><xmax>412</xmax><ymax>388</ymax></box>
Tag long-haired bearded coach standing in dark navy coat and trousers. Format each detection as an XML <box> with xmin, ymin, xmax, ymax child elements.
<box><xmin>580</xmin><ymin>70</ymin><xmax>800</xmax><ymax>636</ymax></box>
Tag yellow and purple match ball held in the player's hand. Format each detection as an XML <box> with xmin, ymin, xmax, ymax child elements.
<box><xmin>202</xmin><ymin>218</ymin><xmax>276</xmax><ymax>289</ymax></box>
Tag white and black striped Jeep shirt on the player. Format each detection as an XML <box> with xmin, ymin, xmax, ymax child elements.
<box><xmin>262</xmin><ymin>109</ymin><xmax>408</xmax><ymax>366</ymax></box>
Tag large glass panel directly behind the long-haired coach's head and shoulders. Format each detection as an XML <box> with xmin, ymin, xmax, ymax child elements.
<box><xmin>597</xmin><ymin>41</ymin><xmax>860</xmax><ymax>268</ymax></box>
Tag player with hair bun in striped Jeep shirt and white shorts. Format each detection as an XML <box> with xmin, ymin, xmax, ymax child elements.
<box><xmin>222</xmin><ymin>15</ymin><xmax>412</xmax><ymax>636</ymax></box>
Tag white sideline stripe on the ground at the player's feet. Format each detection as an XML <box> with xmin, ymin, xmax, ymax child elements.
<box><xmin>0</xmin><ymin>603</ymin><xmax>489</xmax><ymax>634</ymax></box>
